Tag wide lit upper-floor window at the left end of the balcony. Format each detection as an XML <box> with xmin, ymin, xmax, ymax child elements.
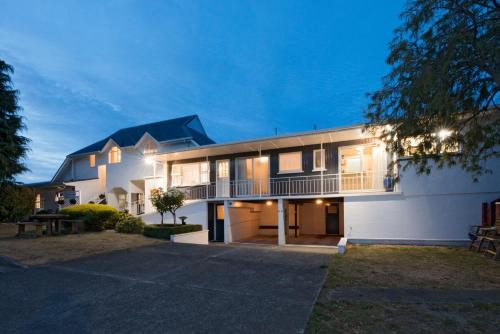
<box><xmin>171</xmin><ymin>162</ymin><xmax>210</xmax><ymax>187</ymax></box>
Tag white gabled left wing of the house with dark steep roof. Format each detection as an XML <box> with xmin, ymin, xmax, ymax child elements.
<box><xmin>48</xmin><ymin>116</ymin><xmax>214</xmax><ymax>214</ymax></box>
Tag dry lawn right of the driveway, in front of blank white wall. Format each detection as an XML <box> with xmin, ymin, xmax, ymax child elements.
<box><xmin>306</xmin><ymin>246</ymin><xmax>500</xmax><ymax>333</ymax></box>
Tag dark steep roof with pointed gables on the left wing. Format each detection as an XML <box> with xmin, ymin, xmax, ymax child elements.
<box><xmin>70</xmin><ymin>115</ymin><xmax>215</xmax><ymax>156</ymax></box>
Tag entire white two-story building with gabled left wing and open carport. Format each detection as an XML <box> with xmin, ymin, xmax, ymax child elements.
<box><xmin>35</xmin><ymin>116</ymin><xmax>500</xmax><ymax>245</ymax></box>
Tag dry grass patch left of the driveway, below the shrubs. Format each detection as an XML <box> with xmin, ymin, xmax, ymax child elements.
<box><xmin>0</xmin><ymin>224</ymin><xmax>164</xmax><ymax>265</ymax></box>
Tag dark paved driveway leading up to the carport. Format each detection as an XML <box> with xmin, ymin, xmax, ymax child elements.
<box><xmin>0</xmin><ymin>243</ymin><xmax>331</xmax><ymax>334</ymax></box>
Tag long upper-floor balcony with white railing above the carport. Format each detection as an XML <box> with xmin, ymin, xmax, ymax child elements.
<box><xmin>178</xmin><ymin>172</ymin><xmax>387</xmax><ymax>200</ymax></box>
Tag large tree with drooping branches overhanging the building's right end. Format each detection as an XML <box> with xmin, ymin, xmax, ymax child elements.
<box><xmin>366</xmin><ymin>0</ymin><xmax>500</xmax><ymax>180</ymax></box>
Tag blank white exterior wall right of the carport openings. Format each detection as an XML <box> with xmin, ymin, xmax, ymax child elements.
<box><xmin>344</xmin><ymin>160</ymin><xmax>500</xmax><ymax>243</ymax></box>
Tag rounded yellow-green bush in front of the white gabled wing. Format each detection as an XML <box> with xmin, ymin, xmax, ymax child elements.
<box><xmin>60</xmin><ymin>204</ymin><xmax>118</xmax><ymax>231</ymax></box>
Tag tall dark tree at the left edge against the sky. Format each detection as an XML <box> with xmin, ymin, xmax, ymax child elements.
<box><xmin>0</xmin><ymin>59</ymin><xmax>29</xmax><ymax>183</ymax></box>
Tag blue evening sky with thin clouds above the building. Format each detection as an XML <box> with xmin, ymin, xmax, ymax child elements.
<box><xmin>0</xmin><ymin>0</ymin><xmax>403</xmax><ymax>182</ymax></box>
